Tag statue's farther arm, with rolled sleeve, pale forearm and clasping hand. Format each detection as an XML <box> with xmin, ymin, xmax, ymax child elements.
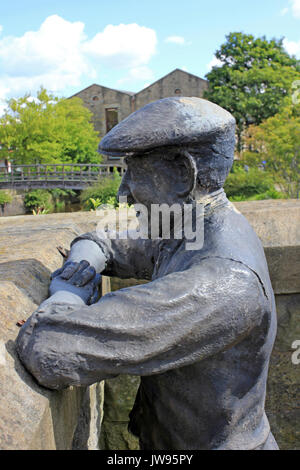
<box><xmin>42</xmin><ymin>232</ymin><xmax>159</xmax><ymax>306</ymax></box>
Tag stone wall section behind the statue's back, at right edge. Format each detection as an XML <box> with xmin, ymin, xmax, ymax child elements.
<box><xmin>235</xmin><ymin>200</ymin><xmax>300</xmax><ymax>449</ymax></box>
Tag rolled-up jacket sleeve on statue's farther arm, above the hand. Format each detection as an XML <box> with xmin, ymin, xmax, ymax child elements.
<box><xmin>71</xmin><ymin>232</ymin><xmax>161</xmax><ymax>279</ymax></box>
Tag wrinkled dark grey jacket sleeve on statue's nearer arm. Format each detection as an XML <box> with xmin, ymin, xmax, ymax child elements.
<box><xmin>17</xmin><ymin>258</ymin><xmax>270</xmax><ymax>389</ymax></box>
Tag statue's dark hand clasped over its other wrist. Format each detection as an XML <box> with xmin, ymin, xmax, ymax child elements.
<box><xmin>49</xmin><ymin>260</ymin><xmax>101</xmax><ymax>305</ymax></box>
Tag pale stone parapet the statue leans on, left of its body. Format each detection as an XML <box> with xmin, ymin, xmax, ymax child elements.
<box><xmin>0</xmin><ymin>213</ymin><xmax>104</xmax><ymax>450</ymax></box>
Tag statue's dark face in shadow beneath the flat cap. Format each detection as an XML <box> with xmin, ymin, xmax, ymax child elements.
<box><xmin>118</xmin><ymin>153</ymin><xmax>190</xmax><ymax>209</ymax></box>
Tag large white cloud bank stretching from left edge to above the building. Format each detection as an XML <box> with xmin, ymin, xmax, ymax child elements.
<box><xmin>0</xmin><ymin>15</ymin><xmax>157</xmax><ymax>114</ymax></box>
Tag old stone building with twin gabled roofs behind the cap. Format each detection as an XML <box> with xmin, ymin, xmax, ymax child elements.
<box><xmin>72</xmin><ymin>69</ymin><xmax>208</xmax><ymax>165</ymax></box>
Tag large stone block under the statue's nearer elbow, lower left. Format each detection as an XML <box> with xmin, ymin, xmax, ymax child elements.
<box><xmin>0</xmin><ymin>278</ymin><xmax>103</xmax><ymax>450</ymax></box>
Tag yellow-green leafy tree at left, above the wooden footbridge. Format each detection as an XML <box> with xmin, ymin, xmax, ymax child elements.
<box><xmin>0</xmin><ymin>88</ymin><xmax>100</xmax><ymax>164</ymax></box>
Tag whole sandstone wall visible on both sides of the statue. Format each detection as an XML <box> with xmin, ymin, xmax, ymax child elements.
<box><xmin>0</xmin><ymin>201</ymin><xmax>300</xmax><ymax>449</ymax></box>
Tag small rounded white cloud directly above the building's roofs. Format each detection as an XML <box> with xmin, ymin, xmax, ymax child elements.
<box><xmin>83</xmin><ymin>23</ymin><xmax>157</xmax><ymax>68</ymax></box>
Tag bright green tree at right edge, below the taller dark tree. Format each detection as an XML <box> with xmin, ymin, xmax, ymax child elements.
<box><xmin>242</xmin><ymin>103</ymin><xmax>300</xmax><ymax>199</ymax></box>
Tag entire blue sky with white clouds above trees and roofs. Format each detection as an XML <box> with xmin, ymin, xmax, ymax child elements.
<box><xmin>0</xmin><ymin>0</ymin><xmax>300</xmax><ymax>115</ymax></box>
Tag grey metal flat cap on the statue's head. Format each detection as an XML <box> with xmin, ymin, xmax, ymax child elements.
<box><xmin>99</xmin><ymin>97</ymin><xmax>235</xmax><ymax>156</ymax></box>
